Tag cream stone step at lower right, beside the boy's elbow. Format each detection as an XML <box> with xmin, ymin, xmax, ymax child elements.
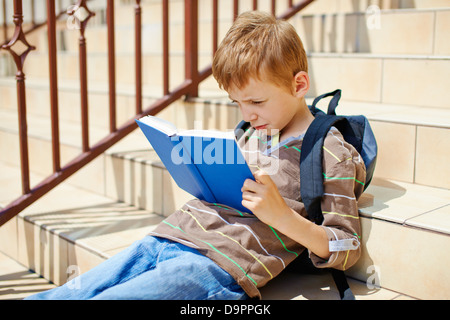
<box><xmin>354</xmin><ymin>179</ymin><xmax>450</xmax><ymax>299</ymax></box>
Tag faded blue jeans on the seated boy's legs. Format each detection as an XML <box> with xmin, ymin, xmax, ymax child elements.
<box><xmin>26</xmin><ymin>236</ymin><xmax>248</xmax><ymax>300</ymax></box>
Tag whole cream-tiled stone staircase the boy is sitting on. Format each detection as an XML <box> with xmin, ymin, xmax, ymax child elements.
<box><xmin>0</xmin><ymin>0</ymin><xmax>450</xmax><ymax>299</ymax></box>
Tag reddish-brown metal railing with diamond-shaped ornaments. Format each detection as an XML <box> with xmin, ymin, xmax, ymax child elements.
<box><xmin>0</xmin><ymin>0</ymin><xmax>313</xmax><ymax>226</ymax></box>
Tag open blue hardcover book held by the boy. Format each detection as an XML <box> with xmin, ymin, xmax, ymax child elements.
<box><xmin>136</xmin><ymin>116</ymin><xmax>254</xmax><ymax>212</ymax></box>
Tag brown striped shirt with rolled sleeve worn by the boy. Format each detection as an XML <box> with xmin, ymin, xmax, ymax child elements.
<box><xmin>150</xmin><ymin>124</ymin><xmax>365</xmax><ymax>297</ymax></box>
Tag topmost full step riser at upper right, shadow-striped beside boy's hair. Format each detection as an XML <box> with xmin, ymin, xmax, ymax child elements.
<box><xmin>291</xmin><ymin>7</ymin><xmax>450</xmax><ymax>56</ymax></box>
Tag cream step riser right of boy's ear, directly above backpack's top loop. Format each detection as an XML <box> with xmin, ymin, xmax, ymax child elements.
<box><xmin>308</xmin><ymin>53</ymin><xmax>450</xmax><ymax>109</ymax></box>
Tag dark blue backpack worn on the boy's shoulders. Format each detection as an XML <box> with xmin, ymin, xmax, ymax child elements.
<box><xmin>300</xmin><ymin>89</ymin><xmax>378</xmax><ymax>300</ymax></box>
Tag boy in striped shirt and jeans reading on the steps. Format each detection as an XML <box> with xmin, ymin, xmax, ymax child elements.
<box><xmin>25</xmin><ymin>12</ymin><xmax>365</xmax><ymax>299</ymax></box>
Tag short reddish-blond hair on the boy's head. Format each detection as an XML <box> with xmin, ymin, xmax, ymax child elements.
<box><xmin>212</xmin><ymin>11</ymin><xmax>308</xmax><ymax>90</ymax></box>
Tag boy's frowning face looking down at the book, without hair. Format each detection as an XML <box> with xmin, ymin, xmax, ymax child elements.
<box><xmin>228</xmin><ymin>78</ymin><xmax>299</xmax><ymax>135</ymax></box>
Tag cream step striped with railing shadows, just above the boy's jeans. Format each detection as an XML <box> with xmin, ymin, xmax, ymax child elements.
<box><xmin>0</xmin><ymin>160</ymin><xmax>167</xmax><ymax>285</ymax></box>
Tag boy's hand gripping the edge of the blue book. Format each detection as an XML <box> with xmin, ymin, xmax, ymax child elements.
<box><xmin>242</xmin><ymin>170</ymin><xmax>291</xmax><ymax>227</ymax></box>
